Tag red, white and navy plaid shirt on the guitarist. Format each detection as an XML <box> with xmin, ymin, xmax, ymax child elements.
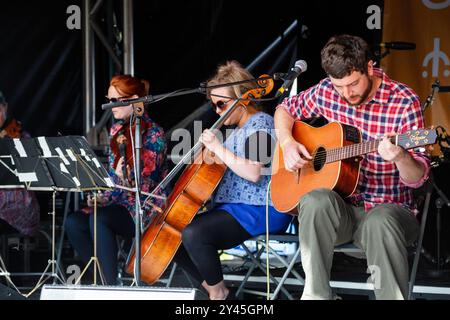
<box><xmin>280</xmin><ymin>68</ymin><xmax>430</xmax><ymax>213</ymax></box>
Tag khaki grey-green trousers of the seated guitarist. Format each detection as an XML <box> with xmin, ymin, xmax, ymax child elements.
<box><xmin>298</xmin><ymin>189</ymin><xmax>419</xmax><ymax>300</ymax></box>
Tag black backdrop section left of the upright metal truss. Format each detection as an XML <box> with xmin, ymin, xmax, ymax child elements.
<box><xmin>0</xmin><ymin>0</ymin><xmax>82</xmax><ymax>136</ymax></box>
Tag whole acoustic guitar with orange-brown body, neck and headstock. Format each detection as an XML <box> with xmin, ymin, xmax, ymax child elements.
<box><xmin>271</xmin><ymin>121</ymin><xmax>437</xmax><ymax>214</ymax></box>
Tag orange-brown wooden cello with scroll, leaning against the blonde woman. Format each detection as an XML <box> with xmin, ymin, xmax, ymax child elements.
<box><xmin>126</xmin><ymin>75</ymin><xmax>274</xmax><ymax>284</ymax></box>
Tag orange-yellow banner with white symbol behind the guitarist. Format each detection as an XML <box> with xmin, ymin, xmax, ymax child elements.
<box><xmin>381</xmin><ymin>0</ymin><xmax>450</xmax><ymax>148</ymax></box>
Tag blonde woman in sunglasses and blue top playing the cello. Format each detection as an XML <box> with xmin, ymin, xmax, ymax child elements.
<box><xmin>174</xmin><ymin>61</ymin><xmax>291</xmax><ymax>300</ymax></box>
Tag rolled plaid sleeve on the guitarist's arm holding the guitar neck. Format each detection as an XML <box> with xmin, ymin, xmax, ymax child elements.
<box><xmin>398</xmin><ymin>99</ymin><xmax>430</xmax><ymax>189</ymax></box>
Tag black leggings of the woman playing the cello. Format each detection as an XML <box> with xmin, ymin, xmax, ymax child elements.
<box><xmin>174</xmin><ymin>210</ymin><xmax>252</xmax><ymax>286</ymax></box>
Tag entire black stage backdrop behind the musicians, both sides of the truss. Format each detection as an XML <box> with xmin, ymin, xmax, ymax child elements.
<box><xmin>0</xmin><ymin>0</ymin><xmax>382</xmax><ymax>136</ymax></box>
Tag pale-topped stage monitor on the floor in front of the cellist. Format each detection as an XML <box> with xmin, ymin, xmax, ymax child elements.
<box><xmin>41</xmin><ymin>285</ymin><xmax>206</xmax><ymax>300</ymax></box>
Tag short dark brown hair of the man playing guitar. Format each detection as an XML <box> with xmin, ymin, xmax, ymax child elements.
<box><xmin>321</xmin><ymin>34</ymin><xmax>371</xmax><ymax>79</ymax></box>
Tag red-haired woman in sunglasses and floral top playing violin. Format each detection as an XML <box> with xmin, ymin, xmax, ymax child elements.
<box><xmin>65</xmin><ymin>75</ymin><xmax>166</xmax><ymax>285</ymax></box>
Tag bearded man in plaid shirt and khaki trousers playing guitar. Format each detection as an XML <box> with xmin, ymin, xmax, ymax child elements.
<box><xmin>272</xmin><ymin>35</ymin><xmax>429</xmax><ymax>299</ymax></box>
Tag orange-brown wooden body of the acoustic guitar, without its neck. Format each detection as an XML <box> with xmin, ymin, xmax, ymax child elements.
<box><xmin>271</xmin><ymin>121</ymin><xmax>361</xmax><ymax>214</ymax></box>
